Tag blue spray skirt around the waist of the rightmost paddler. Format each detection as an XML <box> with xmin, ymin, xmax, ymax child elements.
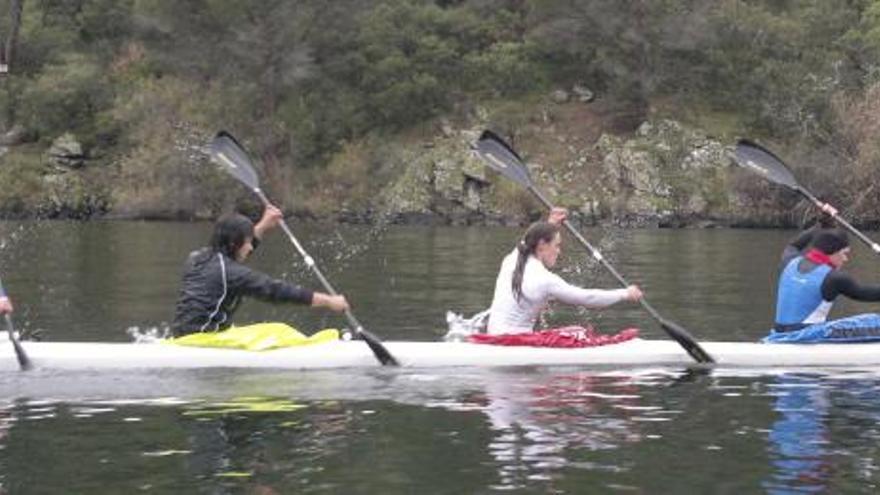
<box><xmin>762</xmin><ymin>313</ymin><xmax>880</xmax><ymax>344</ymax></box>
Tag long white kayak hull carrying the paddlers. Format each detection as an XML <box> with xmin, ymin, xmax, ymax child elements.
<box><xmin>0</xmin><ymin>339</ymin><xmax>880</xmax><ymax>371</ymax></box>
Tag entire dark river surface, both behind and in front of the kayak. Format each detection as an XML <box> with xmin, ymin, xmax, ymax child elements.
<box><xmin>0</xmin><ymin>222</ymin><xmax>880</xmax><ymax>494</ymax></box>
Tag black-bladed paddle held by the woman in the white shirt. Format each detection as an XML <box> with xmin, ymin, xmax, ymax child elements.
<box><xmin>474</xmin><ymin>131</ymin><xmax>715</xmax><ymax>363</ymax></box>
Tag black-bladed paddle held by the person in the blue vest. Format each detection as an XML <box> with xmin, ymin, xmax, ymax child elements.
<box><xmin>734</xmin><ymin>139</ymin><xmax>880</xmax><ymax>254</ymax></box>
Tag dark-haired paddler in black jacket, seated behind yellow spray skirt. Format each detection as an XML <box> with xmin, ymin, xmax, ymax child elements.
<box><xmin>171</xmin><ymin>205</ymin><xmax>348</xmax><ymax>337</ymax></box>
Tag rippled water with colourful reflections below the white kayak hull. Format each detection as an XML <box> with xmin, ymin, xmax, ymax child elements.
<box><xmin>0</xmin><ymin>368</ymin><xmax>880</xmax><ymax>493</ymax></box>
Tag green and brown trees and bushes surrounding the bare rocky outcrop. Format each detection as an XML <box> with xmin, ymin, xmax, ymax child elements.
<box><xmin>0</xmin><ymin>0</ymin><xmax>880</xmax><ymax>218</ymax></box>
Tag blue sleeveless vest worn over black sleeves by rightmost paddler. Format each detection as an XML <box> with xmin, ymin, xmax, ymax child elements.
<box><xmin>776</xmin><ymin>256</ymin><xmax>832</xmax><ymax>326</ymax></box>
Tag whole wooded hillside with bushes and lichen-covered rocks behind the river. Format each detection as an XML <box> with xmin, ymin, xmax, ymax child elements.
<box><xmin>0</xmin><ymin>0</ymin><xmax>880</xmax><ymax>225</ymax></box>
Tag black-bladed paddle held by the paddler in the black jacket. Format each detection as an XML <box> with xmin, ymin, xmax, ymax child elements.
<box><xmin>210</xmin><ymin>131</ymin><xmax>399</xmax><ymax>366</ymax></box>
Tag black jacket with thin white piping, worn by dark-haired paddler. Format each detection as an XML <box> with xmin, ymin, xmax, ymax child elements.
<box><xmin>171</xmin><ymin>248</ymin><xmax>312</xmax><ymax>337</ymax></box>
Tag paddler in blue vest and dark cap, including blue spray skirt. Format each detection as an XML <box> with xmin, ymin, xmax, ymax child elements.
<box><xmin>764</xmin><ymin>207</ymin><xmax>880</xmax><ymax>342</ymax></box>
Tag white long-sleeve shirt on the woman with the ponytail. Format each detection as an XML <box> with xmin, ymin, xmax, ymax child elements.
<box><xmin>488</xmin><ymin>249</ymin><xmax>628</xmax><ymax>334</ymax></box>
